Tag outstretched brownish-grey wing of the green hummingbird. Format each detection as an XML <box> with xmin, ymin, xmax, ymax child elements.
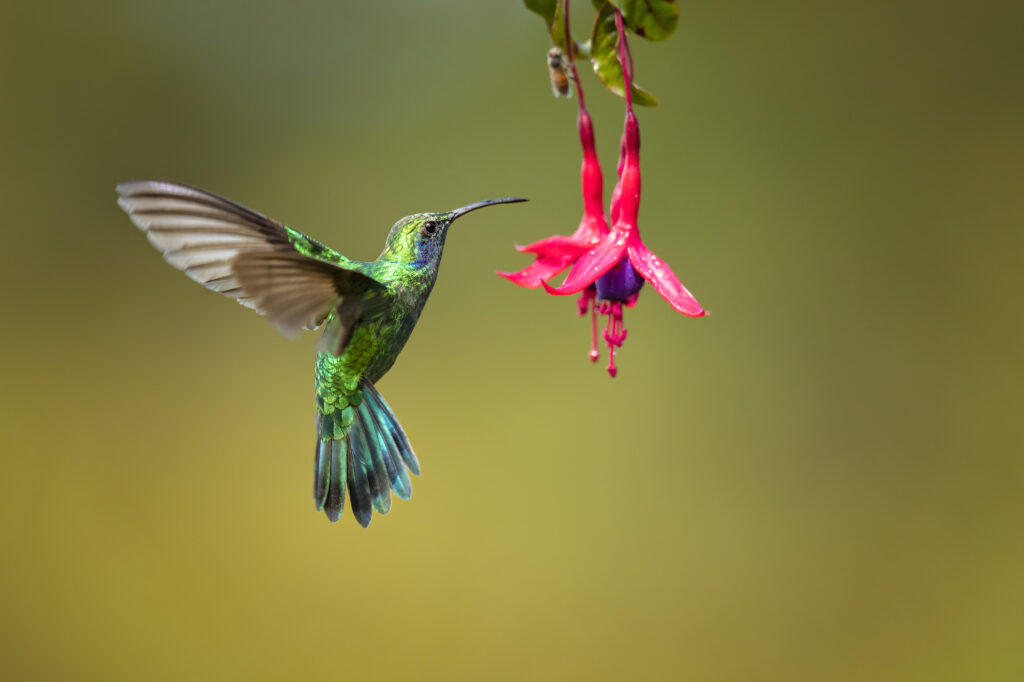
<box><xmin>118</xmin><ymin>180</ymin><xmax>387</xmax><ymax>339</ymax></box>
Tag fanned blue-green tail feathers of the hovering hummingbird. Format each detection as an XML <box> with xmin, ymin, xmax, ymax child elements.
<box><xmin>313</xmin><ymin>381</ymin><xmax>420</xmax><ymax>527</ymax></box>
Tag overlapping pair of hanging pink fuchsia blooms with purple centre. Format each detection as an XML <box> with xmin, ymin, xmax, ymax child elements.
<box><xmin>499</xmin><ymin>11</ymin><xmax>705</xmax><ymax>377</ymax></box>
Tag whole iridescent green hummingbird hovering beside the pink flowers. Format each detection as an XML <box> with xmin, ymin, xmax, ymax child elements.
<box><xmin>117</xmin><ymin>180</ymin><xmax>526</xmax><ymax>527</ymax></box>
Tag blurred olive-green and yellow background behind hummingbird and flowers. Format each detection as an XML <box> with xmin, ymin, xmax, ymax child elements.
<box><xmin>0</xmin><ymin>0</ymin><xmax>1024</xmax><ymax>682</ymax></box>
